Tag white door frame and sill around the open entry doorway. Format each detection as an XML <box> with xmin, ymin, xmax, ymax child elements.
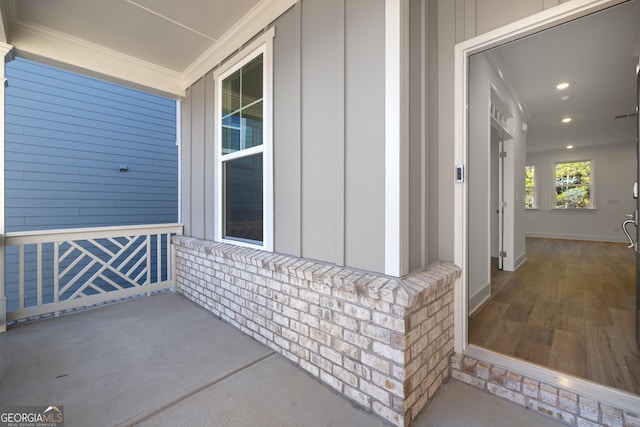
<box><xmin>454</xmin><ymin>0</ymin><xmax>640</xmax><ymax>410</ymax></box>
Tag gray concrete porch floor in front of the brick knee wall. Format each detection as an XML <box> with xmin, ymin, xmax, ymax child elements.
<box><xmin>0</xmin><ymin>293</ymin><xmax>561</xmax><ymax>427</ymax></box>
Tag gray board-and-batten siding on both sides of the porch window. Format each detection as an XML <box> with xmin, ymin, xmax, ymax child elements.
<box><xmin>181</xmin><ymin>0</ymin><xmax>385</xmax><ymax>272</ymax></box>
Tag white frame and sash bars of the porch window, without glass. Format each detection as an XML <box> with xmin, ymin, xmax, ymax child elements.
<box><xmin>213</xmin><ymin>28</ymin><xmax>275</xmax><ymax>252</ymax></box>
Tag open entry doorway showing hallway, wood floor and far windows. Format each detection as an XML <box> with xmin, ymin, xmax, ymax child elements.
<box><xmin>467</xmin><ymin>0</ymin><xmax>640</xmax><ymax>394</ymax></box>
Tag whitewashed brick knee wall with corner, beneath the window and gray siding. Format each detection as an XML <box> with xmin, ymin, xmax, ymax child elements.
<box><xmin>172</xmin><ymin>236</ymin><xmax>460</xmax><ymax>426</ymax></box>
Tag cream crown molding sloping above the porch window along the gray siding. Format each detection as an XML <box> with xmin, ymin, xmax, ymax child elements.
<box><xmin>182</xmin><ymin>0</ymin><xmax>298</xmax><ymax>89</ymax></box>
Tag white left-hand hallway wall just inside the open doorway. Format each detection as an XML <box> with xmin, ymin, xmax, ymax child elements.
<box><xmin>468</xmin><ymin>55</ymin><xmax>526</xmax><ymax>312</ymax></box>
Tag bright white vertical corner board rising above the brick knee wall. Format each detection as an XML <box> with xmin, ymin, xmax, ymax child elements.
<box><xmin>385</xmin><ymin>0</ymin><xmax>409</xmax><ymax>277</ymax></box>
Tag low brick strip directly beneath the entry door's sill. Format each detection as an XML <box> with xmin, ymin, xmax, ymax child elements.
<box><xmin>451</xmin><ymin>354</ymin><xmax>640</xmax><ymax>427</ymax></box>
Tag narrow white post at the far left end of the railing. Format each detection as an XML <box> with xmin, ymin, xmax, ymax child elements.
<box><xmin>0</xmin><ymin>43</ymin><xmax>14</xmax><ymax>333</ymax></box>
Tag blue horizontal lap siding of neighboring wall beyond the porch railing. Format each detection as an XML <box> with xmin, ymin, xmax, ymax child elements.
<box><xmin>5</xmin><ymin>58</ymin><xmax>178</xmax><ymax>310</ymax></box>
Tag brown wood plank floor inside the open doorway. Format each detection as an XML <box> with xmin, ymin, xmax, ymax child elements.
<box><xmin>469</xmin><ymin>238</ymin><xmax>640</xmax><ymax>394</ymax></box>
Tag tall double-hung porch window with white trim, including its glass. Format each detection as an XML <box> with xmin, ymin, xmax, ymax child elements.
<box><xmin>215</xmin><ymin>34</ymin><xmax>273</xmax><ymax>250</ymax></box>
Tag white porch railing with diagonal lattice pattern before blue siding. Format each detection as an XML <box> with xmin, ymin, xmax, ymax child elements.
<box><xmin>5</xmin><ymin>224</ymin><xmax>183</xmax><ymax>321</ymax></box>
